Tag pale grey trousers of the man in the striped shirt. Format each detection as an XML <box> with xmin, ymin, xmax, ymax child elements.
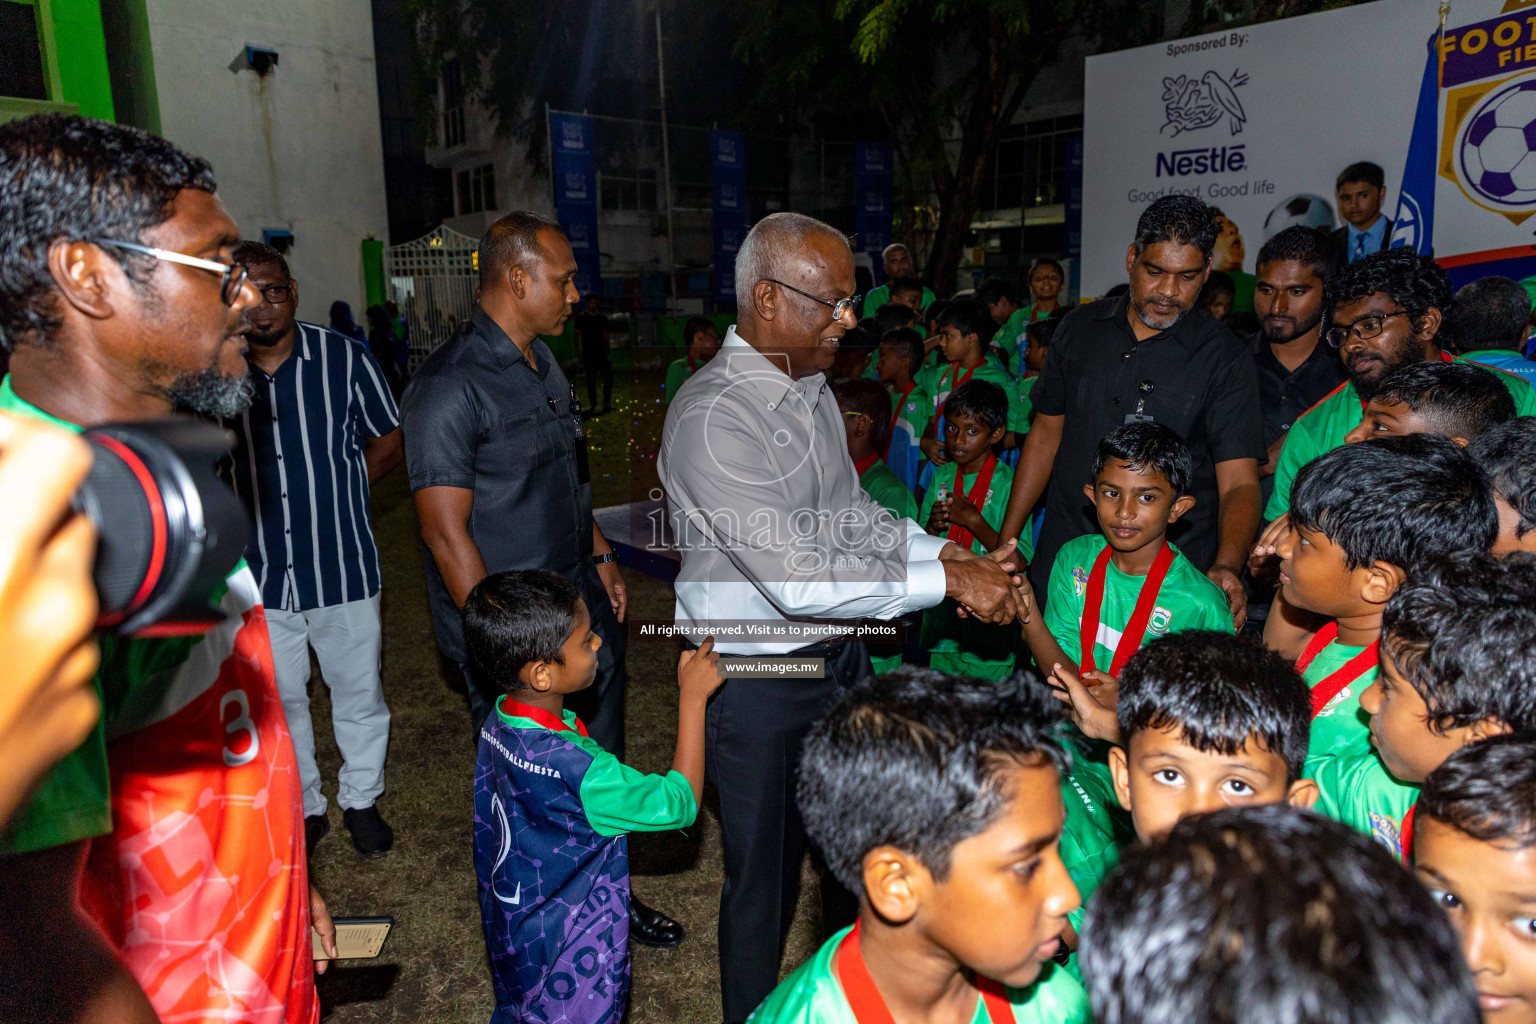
<box><xmin>266</xmin><ymin>594</ymin><xmax>389</xmax><ymax>817</ymax></box>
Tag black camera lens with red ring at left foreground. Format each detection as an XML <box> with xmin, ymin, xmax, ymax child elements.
<box><xmin>74</xmin><ymin>416</ymin><xmax>249</xmax><ymax>636</ymax></box>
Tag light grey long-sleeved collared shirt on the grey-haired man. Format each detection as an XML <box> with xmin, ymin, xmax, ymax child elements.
<box><xmin>656</xmin><ymin>327</ymin><xmax>948</xmax><ymax>654</ymax></box>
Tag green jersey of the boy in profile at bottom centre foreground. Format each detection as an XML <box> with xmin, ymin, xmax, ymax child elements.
<box><xmin>746</xmin><ymin>929</ymin><xmax>1091</xmax><ymax>1024</ymax></box>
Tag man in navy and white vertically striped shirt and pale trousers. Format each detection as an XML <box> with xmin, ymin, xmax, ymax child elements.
<box><xmin>224</xmin><ymin>241</ymin><xmax>404</xmax><ymax>857</ymax></box>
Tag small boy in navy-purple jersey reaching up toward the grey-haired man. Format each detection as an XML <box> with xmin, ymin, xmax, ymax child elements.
<box><xmin>464</xmin><ymin>570</ymin><xmax>722</xmax><ymax>1024</ymax></box>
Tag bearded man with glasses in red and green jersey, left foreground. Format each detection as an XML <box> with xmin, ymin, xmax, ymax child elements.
<box><xmin>0</xmin><ymin>114</ymin><xmax>324</xmax><ymax>1024</ymax></box>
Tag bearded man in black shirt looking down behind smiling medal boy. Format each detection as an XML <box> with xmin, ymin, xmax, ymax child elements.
<box><xmin>1003</xmin><ymin>195</ymin><xmax>1264</xmax><ymax>623</ymax></box>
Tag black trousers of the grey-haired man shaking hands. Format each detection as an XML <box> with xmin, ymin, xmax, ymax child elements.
<box><xmin>705</xmin><ymin>640</ymin><xmax>874</xmax><ymax>1021</ymax></box>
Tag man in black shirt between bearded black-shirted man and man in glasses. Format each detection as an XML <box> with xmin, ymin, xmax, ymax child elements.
<box><xmin>1249</xmin><ymin>224</ymin><xmax>1349</xmax><ymax>502</ymax></box>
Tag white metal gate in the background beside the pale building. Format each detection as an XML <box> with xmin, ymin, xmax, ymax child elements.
<box><xmin>384</xmin><ymin>226</ymin><xmax>479</xmax><ymax>370</ymax></box>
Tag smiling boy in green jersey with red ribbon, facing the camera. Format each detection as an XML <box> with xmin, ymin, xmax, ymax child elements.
<box><xmin>1025</xmin><ymin>424</ymin><xmax>1232</xmax><ymax>693</ymax></box>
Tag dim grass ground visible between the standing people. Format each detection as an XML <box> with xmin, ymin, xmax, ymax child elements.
<box><xmin>312</xmin><ymin>353</ymin><xmax>816</xmax><ymax>1024</ymax></box>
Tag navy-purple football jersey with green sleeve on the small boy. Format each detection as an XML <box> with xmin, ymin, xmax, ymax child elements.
<box><xmin>475</xmin><ymin>697</ymin><xmax>697</xmax><ymax>1024</ymax></box>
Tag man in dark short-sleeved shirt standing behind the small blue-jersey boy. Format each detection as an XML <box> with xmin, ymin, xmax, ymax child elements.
<box><xmin>401</xmin><ymin>212</ymin><xmax>682</xmax><ymax>946</ymax></box>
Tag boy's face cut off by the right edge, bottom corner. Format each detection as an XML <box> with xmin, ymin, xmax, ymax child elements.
<box><xmin>1413</xmin><ymin>734</ymin><xmax>1536</xmax><ymax>1024</ymax></box>
